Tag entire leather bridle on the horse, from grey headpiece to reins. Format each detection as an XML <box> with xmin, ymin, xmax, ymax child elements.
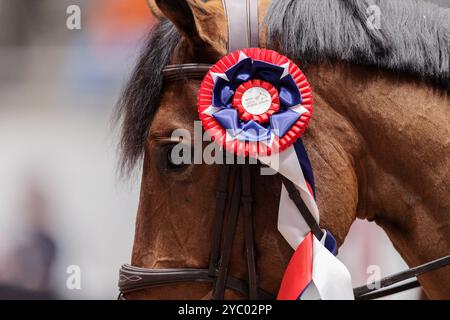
<box><xmin>119</xmin><ymin>0</ymin><xmax>450</xmax><ymax>300</ymax></box>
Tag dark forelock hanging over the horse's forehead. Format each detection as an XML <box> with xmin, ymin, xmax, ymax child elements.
<box><xmin>115</xmin><ymin>20</ymin><xmax>180</xmax><ymax>174</ymax></box>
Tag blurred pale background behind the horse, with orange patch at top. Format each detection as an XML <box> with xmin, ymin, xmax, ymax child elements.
<box><xmin>0</xmin><ymin>0</ymin><xmax>450</xmax><ymax>299</ymax></box>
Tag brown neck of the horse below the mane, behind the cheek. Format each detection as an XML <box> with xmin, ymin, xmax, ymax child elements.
<box><xmin>307</xmin><ymin>64</ymin><xmax>450</xmax><ymax>298</ymax></box>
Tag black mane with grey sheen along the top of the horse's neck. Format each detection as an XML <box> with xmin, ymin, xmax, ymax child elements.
<box><xmin>266</xmin><ymin>0</ymin><xmax>450</xmax><ymax>87</ymax></box>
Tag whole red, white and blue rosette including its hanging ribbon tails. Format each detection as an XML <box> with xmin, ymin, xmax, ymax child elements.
<box><xmin>198</xmin><ymin>48</ymin><xmax>353</xmax><ymax>300</ymax></box>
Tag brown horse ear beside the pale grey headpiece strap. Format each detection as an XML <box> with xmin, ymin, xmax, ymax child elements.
<box><xmin>155</xmin><ymin>0</ymin><xmax>226</xmax><ymax>54</ymax></box>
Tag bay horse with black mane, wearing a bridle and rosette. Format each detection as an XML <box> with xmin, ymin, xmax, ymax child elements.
<box><xmin>117</xmin><ymin>0</ymin><xmax>450</xmax><ymax>299</ymax></box>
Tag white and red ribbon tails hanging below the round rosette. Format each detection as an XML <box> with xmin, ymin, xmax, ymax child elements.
<box><xmin>259</xmin><ymin>146</ymin><xmax>354</xmax><ymax>300</ymax></box>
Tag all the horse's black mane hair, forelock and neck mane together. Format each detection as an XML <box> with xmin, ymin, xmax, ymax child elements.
<box><xmin>117</xmin><ymin>0</ymin><xmax>450</xmax><ymax>173</ymax></box>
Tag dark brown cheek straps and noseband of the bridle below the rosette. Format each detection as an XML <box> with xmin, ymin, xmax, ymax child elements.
<box><xmin>119</xmin><ymin>164</ymin><xmax>273</xmax><ymax>299</ymax></box>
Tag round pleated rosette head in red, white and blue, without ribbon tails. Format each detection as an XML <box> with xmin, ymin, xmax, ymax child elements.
<box><xmin>198</xmin><ymin>48</ymin><xmax>313</xmax><ymax>157</ymax></box>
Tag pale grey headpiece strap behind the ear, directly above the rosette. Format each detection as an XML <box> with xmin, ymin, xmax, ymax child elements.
<box><xmin>222</xmin><ymin>0</ymin><xmax>259</xmax><ymax>52</ymax></box>
